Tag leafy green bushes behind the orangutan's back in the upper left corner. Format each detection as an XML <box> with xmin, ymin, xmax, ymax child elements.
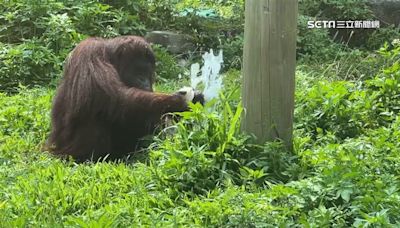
<box><xmin>0</xmin><ymin>0</ymin><xmax>145</xmax><ymax>92</ymax></box>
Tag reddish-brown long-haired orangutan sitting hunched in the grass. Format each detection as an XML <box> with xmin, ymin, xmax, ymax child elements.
<box><xmin>48</xmin><ymin>36</ymin><xmax>191</xmax><ymax>161</ymax></box>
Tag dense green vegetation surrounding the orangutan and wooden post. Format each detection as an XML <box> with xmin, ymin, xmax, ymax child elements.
<box><xmin>0</xmin><ymin>0</ymin><xmax>400</xmax><ymax>227</ymax></box>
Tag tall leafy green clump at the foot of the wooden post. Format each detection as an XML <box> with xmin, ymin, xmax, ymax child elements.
<box><xmin>150</xmin><ymin>98</ymin><xmax>290</xmax><ymax>196</ymax></box>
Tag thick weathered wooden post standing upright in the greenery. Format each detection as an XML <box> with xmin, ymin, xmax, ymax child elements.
<box><xmin>242</xmin><ymin>0</ymin><xmax>297</xmax><ymax>148</ymax></box>
